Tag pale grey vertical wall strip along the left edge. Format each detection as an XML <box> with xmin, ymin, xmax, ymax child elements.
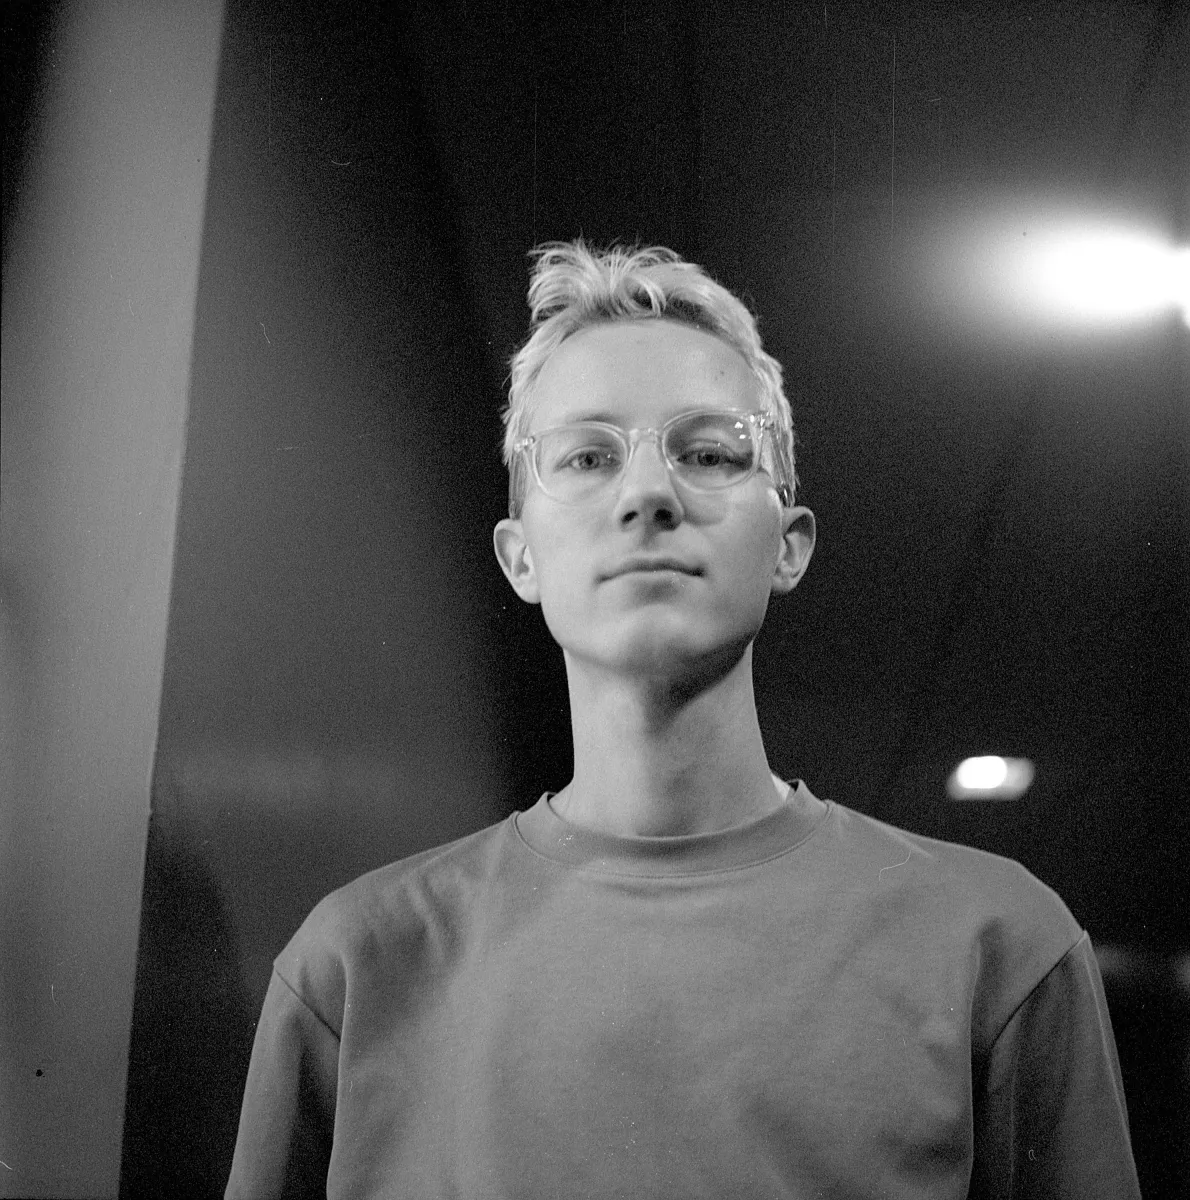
<box><xmin>0</xmin><ymin>0</ymin><xmax>221</xmax><ymax>1196</ymax></box>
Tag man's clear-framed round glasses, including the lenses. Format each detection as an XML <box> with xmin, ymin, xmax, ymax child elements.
<box><xmin>513</xmin><ymin>408</ymin><xmax>793</xmax><ymax>505</ymax></box>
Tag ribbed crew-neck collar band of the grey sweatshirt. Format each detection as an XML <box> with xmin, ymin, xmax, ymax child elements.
<box><xmin>512</xmin><ymin>779</ymin><xmax>830</xmax><ymax>875</ymax></box>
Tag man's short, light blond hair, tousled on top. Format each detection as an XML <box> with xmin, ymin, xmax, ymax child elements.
<box><xmin>504</xmin><ymin>238</ymin><xmax>794</xmax><ymax>516</ymax></box>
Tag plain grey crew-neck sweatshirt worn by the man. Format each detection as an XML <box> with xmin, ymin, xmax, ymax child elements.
<box><xmin>227</xmin><ymin>782</ymin><xmax>1140</xmax><ymax>1200</ymax></box>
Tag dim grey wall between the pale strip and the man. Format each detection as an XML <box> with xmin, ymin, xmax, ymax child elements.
<box><xmin>121</xmin><ymin>4</ymin><xmax>509</xmax><ymax>1196</ymax></box>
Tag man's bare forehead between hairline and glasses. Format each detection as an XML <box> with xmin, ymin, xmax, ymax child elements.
<box><xmin>530</xmin><ymin>318</ymin><xmax>759</xmax><ymax>430</ymax></box>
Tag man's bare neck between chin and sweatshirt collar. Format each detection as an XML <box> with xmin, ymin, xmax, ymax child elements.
<box><xmin>554</xmin><ymin>647</ymin><xmax>783</xmax><ymax>838</ymax></box>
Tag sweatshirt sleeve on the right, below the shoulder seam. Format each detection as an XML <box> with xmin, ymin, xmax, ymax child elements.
<box><xmin>969</xmin><ymin>934</ymin><xmax>1141</xmax><ymax>1200</ymax></box>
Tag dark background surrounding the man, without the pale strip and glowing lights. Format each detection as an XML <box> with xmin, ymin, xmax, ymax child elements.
<box><xmin>5</xmin><ymin>0</ymin><xmax>1190</xmax><ymax>1196</ymax></box>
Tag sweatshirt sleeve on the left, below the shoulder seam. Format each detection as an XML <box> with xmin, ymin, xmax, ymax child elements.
<box><xmin>224</xmin><ymin>971</ymin><xmax>339</xmax><ymax>1200</ymax></box>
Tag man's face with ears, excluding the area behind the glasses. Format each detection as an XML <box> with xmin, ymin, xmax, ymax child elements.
<box><xmin>495</xmin><ymin>320</ymin><xmax>813</xmax><ymax>677</ymax></box>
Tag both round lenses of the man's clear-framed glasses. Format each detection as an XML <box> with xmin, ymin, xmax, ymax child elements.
<box><xmin>534</xmin><ymin>413</ymin><xmax>756</xmax><ymax>503</ymax></box>
